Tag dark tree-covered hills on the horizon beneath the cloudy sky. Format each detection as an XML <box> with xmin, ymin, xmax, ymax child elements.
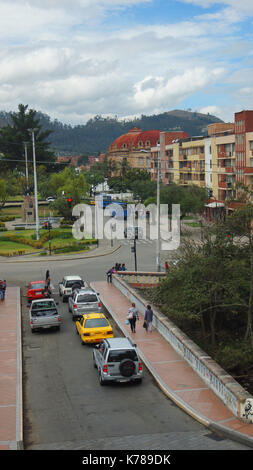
<box><xmin>0</xmin><ymin>110</ymin><xmax>222</xmax><ymax>155</ymax></box>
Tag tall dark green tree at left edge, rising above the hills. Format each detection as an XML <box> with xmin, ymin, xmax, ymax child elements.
<box><xmin>0</xmin><ymin>104</ymin><xmax>56</xmax><ymax>172</ymax></box>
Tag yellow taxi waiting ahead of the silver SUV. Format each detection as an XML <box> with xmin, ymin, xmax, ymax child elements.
<box><xmin>76</xmin><ymin>312</ymin><xmax>114</xmax><ymax>344</ymax></box>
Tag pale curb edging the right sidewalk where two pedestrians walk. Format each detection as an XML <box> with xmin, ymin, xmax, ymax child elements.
<box><xmin>94</xmin><ymin>283</ymin><xmax>253</xmax><ymax>448</ymax></box>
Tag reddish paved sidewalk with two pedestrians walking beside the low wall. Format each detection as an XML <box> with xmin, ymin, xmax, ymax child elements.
<box><xmin>92</xmin><ymin>282</ymin><xmax>253</xmax><ymax>447</ymax></box>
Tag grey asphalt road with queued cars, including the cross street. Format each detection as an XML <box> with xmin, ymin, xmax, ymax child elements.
<box><xmin>0</xmin><ymin>242</ymin><xmax>251</xmax><ymax>450</ymax></box>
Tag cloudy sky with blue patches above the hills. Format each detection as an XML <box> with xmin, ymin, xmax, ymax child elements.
<box><xmin>0</xmin><ymin>0</ymin><xmax>253</xmax><ymax>125</ymax></box>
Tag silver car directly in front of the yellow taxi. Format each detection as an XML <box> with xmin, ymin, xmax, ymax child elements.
<box><xmin>68</xmin><ymin>288</ymin><xmax>102</xmax><ymax>320</ymax></box>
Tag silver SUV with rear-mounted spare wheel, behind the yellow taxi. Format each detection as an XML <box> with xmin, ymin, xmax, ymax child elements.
<box><xmin>93</xmin><ymin>338</ymin><xmax>142</xmax><ymax>385</ymax></box>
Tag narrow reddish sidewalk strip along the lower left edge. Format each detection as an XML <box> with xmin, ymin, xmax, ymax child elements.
<box><xmin>0</xmin><ymin>287</ymin><xmax>23</xmax><ymax>450</ymax></box>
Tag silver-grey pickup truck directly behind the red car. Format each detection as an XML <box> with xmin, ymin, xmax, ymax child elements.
<box><xmin>29</xmin><ymin>299</ymin><xmax>62</xmax><ymax>333</ymax></box>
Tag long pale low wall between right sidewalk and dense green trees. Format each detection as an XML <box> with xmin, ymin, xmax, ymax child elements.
<box><xmin>112</xmin><ymin>273</ymin><xmax>253</xmax><ymax>423</ymax></box>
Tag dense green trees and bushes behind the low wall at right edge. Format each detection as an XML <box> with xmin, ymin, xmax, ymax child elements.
<box><xmin>142</xmin><ymin>203</ymin><xmax>253</xmax><ymax>389</ymax></box>
